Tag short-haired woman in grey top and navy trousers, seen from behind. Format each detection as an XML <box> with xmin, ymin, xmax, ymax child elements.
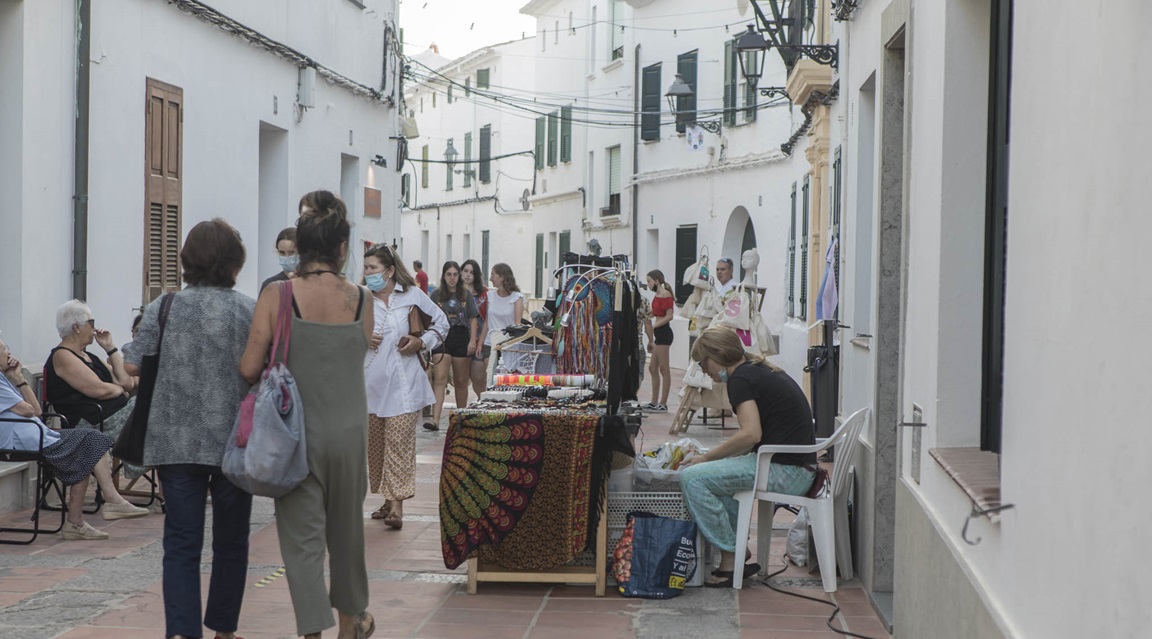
<box><xmin>124</xmin><ymin>218</ymin><xmax>256</xmax><ymax>639</ymax></box>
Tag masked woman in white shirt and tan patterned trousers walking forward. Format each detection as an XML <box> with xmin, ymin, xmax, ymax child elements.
<box><xmin>364</xmin><ymin>244</ymin><xmax>448</xmax><ymax>530</ymax></box>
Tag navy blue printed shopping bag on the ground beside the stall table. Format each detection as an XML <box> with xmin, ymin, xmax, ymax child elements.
<box><xmin>611</xmin><ymin>512</ymin><xmax>696</xmax><ymax>599</ymax></box>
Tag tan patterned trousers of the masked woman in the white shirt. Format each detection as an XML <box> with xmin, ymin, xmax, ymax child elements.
<box><xmin>367</xmin><ymin>411</ymin><xmax>420</xmax><ymax>500</ymax></box>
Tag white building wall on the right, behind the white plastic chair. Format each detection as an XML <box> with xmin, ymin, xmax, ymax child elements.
<box><xmin>833</xmin><ymin>0</ymin><xmax>1152</xmax><ymax>639</ymax></box>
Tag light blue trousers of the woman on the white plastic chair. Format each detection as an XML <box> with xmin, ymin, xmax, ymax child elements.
<box><xmin>680</xmin><ymin>452</ymin><xmax>816</xmax><ymax>553</ymax></box>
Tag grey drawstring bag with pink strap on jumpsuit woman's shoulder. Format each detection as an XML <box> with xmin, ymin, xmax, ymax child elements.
<box><xmin>221</xmin><ymin>280</ymin><xmax>308</xmax><ymax>497</ymax></box>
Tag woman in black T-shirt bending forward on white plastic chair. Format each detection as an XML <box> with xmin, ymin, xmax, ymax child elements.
<box><xmin>680</xmin><ymin>326</ymin><xmax>816</xmax><ymax>587</ymax></box>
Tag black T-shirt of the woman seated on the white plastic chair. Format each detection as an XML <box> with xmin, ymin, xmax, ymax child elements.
<box><xmin>728</xmin><ymin>363</ymin><xmax>816</xmax><ymax>466</ymax></box>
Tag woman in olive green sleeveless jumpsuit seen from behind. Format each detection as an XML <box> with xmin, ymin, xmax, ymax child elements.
<box><xmin>240</xmin><ymin>191</ymin><xmax>376</xmax><ymax>639</ymax></box>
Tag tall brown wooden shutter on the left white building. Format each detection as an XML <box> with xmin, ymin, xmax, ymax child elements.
<box><xmin>143</xmin><ymin>78</ymin><xmax>184</xmax><ymax>304</ymax></box>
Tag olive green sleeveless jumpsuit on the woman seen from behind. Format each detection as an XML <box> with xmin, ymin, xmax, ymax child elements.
<box><xmin>276</xmin><ymin>289</ymin><xmax>369</xmax><ymax>636</ymax></box>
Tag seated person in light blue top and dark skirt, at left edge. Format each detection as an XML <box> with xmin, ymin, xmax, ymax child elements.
<box><xmin>0</xmin><ymin>341</ymin><xmax>147</xmax><ymax>540</ymax></box>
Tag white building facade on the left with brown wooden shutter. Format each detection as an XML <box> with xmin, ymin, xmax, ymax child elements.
<box><xmin>0</xmin><ymin>0</ymin><xmax>400</xmax><ymax>504</ymax></box>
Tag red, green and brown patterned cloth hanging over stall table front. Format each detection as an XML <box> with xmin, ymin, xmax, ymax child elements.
<box><xmin>440</xmin><ymin>410</ymin><xmax>601</xmax><ymax>570</ymax></box>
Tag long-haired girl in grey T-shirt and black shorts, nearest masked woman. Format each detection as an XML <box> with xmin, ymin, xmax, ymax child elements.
<box><xmin>424</xmin><ymin>260</ymin><xmax>479</xmax><ymax>431</ymax></box>
